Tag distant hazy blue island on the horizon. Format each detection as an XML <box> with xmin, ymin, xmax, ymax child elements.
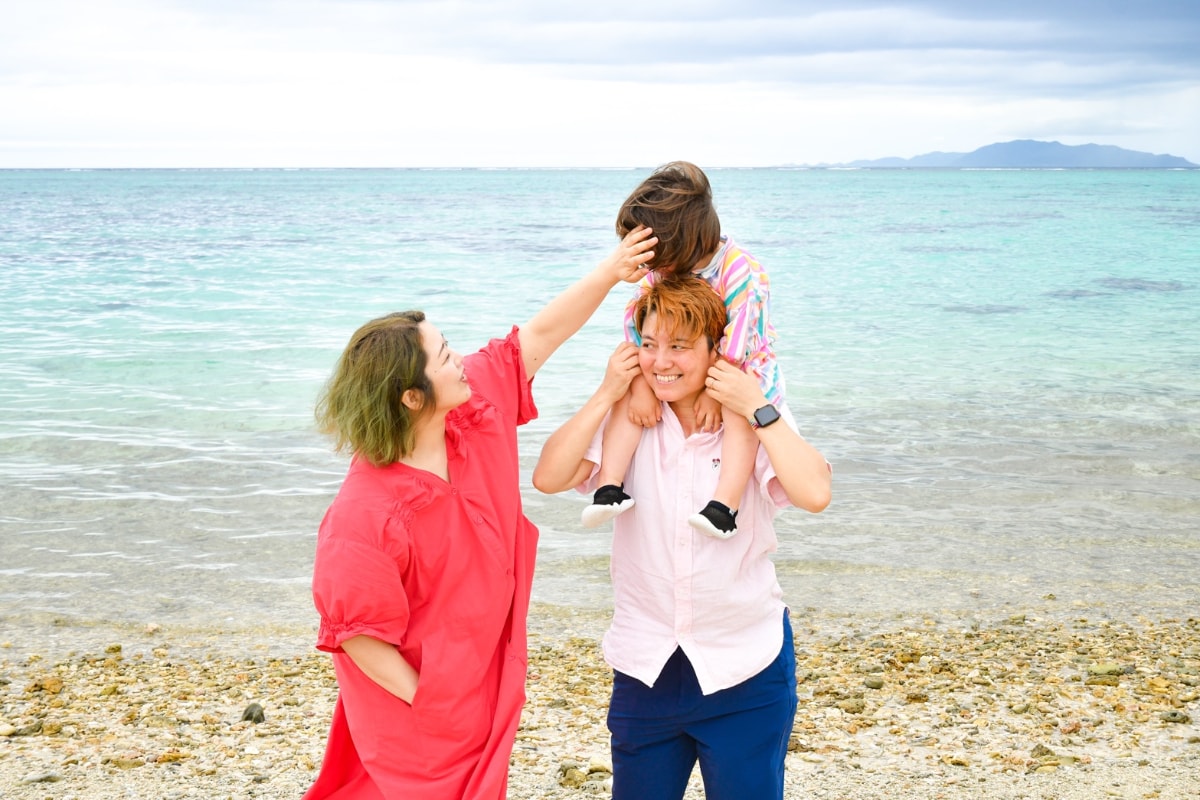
<box><xmin>820</xmin><ymin>139</ymin><xmax>1200</xmax><ymax>169</ymax></box>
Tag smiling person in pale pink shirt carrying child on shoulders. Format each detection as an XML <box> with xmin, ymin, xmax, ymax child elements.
<box><xmin>533</xmin><ymin>278</ymin><xmax>830</xmax><ymax>800</ymax></box>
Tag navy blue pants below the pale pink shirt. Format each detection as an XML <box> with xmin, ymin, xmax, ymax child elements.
<box><xmin>608</xmin><ymin>612</ymin><xmax>796</xmax><ymax>800</ymax></box>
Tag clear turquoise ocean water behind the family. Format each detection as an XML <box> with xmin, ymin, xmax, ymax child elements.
<box><xmin>0</xmin><ymin>169</ymin><xmax>1200</xmax><ymax>628</ymax></box>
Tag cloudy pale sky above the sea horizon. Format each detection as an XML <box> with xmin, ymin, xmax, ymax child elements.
<box><xmin>0</xmin><ymin>0</ymin><xmax>1200</xmax><ymax>168</ymax></box>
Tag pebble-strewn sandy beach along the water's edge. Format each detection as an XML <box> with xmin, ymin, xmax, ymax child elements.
<box><xmin>0</xmin><ymin>606</ymin><xmax>1200</xmax><ymax>800</ymax></box>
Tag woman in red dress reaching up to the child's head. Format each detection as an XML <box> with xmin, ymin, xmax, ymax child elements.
<box><xmin>305</xmin><ymin>228</ymin><xmax>658</xmax><ymax>800</ymax></box>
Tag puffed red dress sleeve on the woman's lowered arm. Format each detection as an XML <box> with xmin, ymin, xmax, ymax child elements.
<box><xmin>312</xmin><ymin>515</ymin><xmax>409</xmax><ymax>652</ymax></box>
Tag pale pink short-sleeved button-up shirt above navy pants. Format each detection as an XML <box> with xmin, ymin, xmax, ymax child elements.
<box><xmin>577</xmin><ymin>403</ymin><xmax>796</xmax><ymax>694</ymax></box>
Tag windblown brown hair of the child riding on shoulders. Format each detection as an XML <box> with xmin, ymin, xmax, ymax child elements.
<box><xmin>617</xmin><ymin>161</ymin><xmax>721</xmax><ymax>275</ymax></box>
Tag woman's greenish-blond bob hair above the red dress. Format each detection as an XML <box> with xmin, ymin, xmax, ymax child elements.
<box><xmin>316</xmin><ymin>311</ymin><xmax>434</xmax><ymax>467</ymax></box>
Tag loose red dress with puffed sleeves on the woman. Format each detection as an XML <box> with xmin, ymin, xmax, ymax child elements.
<box><xmin>304</xmin><ymin>327</ymin><xmax>538</xmax><ymax>800</ymax></box>
